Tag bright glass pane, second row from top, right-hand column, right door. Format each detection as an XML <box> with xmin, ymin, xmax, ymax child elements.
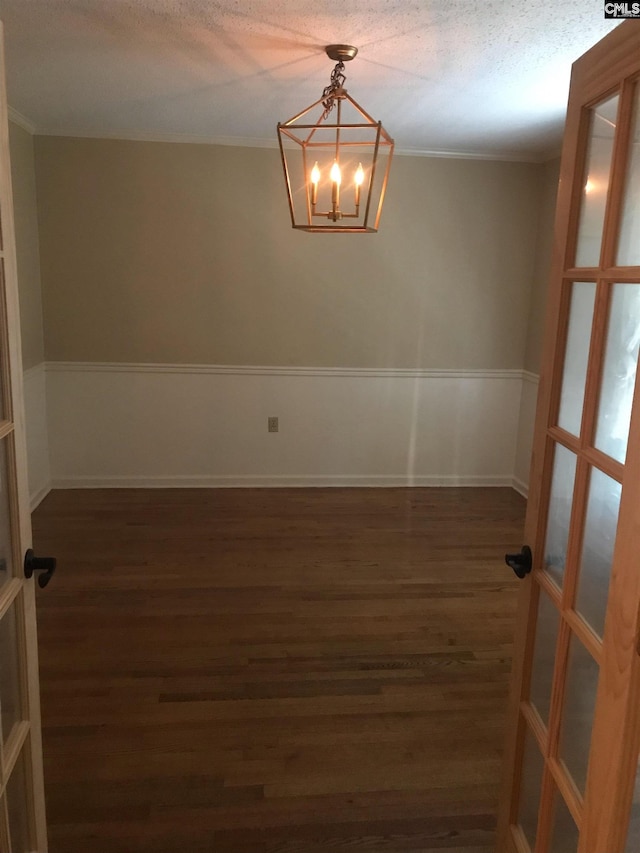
<box><xmin>595</xmin><ymin>284</ymin><xmax>640</xmax><ymax>462</ymax></box>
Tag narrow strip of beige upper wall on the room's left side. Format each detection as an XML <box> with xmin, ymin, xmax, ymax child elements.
<box><xmin>9</xmin><ymin>122</ymin><xmax>44</xmax><ymax>370</ymax></box>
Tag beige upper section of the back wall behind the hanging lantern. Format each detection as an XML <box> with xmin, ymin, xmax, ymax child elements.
<box><xmin>35</xmin><ymin>137</ymin><xmax>543</xmax><ymax>369</ymax></box>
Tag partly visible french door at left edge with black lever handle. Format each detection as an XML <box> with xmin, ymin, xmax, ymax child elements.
<box><xmin>0</xmin><ymin>18</ymin><xmax>47</xmax><ymax>853</ymax></box>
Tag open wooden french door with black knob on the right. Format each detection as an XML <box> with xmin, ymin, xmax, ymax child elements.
<box><xmin>498</xmin><ymin>21</ymin><xmax>640</xmax><ymax>853</ymax></box>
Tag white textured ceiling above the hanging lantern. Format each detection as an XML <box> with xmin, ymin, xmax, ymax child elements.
<box><xmin>0</xmin><ymin>0</ymin><xmax>617</xmax><ymax>159</ymax></box>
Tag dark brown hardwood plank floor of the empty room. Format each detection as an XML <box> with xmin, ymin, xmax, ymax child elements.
<box><xmin>34</xmin><ymin>489</ymin><xmax>524</xmax><ymax>853</ymax></box>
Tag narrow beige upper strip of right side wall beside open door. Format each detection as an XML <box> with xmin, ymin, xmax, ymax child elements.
<box><xmin>524</xmin><ymin>159</ymin><xmax>560</xmax><ymax>373</ymax></box>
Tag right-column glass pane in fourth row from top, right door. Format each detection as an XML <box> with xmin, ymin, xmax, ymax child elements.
<box><xmin>559</xmin><ymin>636</ymin><xmax>599</xmax><ymax>793</ymax></box>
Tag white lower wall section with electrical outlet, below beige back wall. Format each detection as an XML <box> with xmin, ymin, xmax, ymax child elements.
<box><xmin>47</xmin><ymin>362</ymin><xmax>523</xmax><ymax>488</ymax></box>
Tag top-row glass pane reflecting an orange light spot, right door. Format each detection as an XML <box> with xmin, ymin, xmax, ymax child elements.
<box><xmin>576</xmin><ymin>95</ymin><xmax>618</xmax><ymax>267</ymax></box>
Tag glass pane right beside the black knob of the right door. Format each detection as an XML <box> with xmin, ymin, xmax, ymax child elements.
<box><xmin>544</xmin><ymin>444</ymin><xmax>576</xmax><ymax>586</ymax></box>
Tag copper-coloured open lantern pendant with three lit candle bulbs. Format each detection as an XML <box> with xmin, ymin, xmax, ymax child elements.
<box><xmin>278</xmin><ymin>44</ymin><xmax>394</xmax><ymax>234</ymax></box>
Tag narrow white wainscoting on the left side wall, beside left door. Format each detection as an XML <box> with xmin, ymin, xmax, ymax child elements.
<box><xmin>24</xmin><ymin>364</ymin><xmax>51</xmax><ymax>510</ymax></box>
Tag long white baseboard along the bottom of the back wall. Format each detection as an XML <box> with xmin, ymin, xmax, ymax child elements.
<box><xmin>52</xmin><ymin>475</ymin><xmax>513</xmax><ymax>489</ymax></box>
